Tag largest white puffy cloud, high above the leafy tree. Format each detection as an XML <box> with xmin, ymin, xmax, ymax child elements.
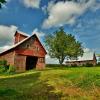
<box><xmin>42</xmin><ymin>0</ymin><xmax>100</xmax><ymax>28</ymax></box>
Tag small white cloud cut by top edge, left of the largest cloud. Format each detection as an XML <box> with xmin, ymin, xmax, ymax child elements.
<box><xmin>23</xmin><ymin>0</ymin><xmax>41</xmax><ymax>8</ymax></box>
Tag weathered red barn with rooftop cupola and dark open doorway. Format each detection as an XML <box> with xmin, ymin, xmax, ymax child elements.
<box><xmin>0</xmin><ymin>31</ymin><xmax>46</xmax><ymax>72</ymax></box>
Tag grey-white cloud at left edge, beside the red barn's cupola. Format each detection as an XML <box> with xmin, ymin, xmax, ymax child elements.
<box><xmin>0</xmin><ymin>25</ymin><xmax>17</xmax><ymax>51</ymax></box>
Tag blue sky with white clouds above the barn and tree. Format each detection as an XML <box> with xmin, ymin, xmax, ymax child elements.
<box><xmin>0</xmin><ymin>0</ymin><xmax>100</xmax><ymax>56</ymax></box>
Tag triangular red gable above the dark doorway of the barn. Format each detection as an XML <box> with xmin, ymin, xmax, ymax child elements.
<box><xmin>16</xmin><ymin>34</ymin><xmax>46</xmax><ymax>57</ymax></box>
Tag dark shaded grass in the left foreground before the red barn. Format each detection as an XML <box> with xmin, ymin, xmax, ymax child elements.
<box><xmin>0</xmin><ymin>72</ymin><xmax>61</xmax><ymax>100</ymax></box>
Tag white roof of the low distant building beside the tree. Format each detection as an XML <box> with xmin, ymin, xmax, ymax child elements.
<box><xmin>67</xmin><ymin>51</ymin><xmax>95</xmax><ymax>62</ymax></box>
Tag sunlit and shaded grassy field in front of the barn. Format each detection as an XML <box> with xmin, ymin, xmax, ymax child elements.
<box><xmin>0</xmin><ymin>67</ymin><xmax>100</xmax><ymax>100</ymax></box>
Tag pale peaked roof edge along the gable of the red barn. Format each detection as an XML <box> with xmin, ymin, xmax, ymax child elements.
<box><xmin>0</xmin><ymin>34</ymin><xmax>47</xmax><ymax>55</ymax></box>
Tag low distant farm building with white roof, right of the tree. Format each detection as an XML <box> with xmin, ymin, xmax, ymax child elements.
<box><xmin>65</xmin><ymin>52</ymin><xmax>97</xmax><ymax>66</ymax></box>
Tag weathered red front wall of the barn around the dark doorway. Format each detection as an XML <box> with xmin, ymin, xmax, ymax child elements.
<box><xmin>15</xmin><ymin>35</ymin><xmax>46</xmax><ymax>71</ymax></box>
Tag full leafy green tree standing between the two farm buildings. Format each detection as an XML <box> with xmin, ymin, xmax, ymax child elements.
<box><xmin>45</xmin><ymin>27</ymin><xmax>83</xmax><ymax>65</ymax></box>
